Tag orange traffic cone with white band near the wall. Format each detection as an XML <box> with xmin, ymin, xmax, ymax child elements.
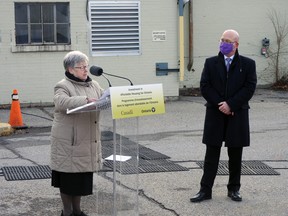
<box><xmin>8</xmin><ymin>89</ymin><xmax>27</xmax><ymax>129</ymax></box>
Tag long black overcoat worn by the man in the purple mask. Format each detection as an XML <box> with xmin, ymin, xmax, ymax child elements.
<box><xmin>200</xmin><ymin>51</ymin><xmax>257</xmax><ymax>147</ymax></box>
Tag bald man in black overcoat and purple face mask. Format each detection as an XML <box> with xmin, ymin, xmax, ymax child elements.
<box><xmin>190</xmin><ymin>30</ymin><xmax>257</xmax><ymax>202</ymax></box>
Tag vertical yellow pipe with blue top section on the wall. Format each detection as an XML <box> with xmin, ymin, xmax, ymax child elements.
<box><xmin>179</xmin><ymin>0</ymin><xmax>184</xmax><ymax>81</ymax></box>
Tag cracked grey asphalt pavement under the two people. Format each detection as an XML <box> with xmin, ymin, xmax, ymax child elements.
<box><xmin>0</xmin><ymin>89</ymin><xmax>288</xmax><ymax>216</ymax></box>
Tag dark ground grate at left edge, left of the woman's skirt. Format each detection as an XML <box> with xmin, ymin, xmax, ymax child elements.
<box><xmin>2</xmin><ymin>165</ymin><xmax>51</xmax><ymax>181</ymax></box>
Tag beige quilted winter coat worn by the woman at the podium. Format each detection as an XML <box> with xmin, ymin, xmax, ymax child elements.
<box><xmin>51</xmin><ymin>77</ymin><xmax>103</xmax><ymax>173</ymax></box>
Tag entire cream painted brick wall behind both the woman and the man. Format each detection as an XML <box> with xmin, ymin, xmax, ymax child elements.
<box><xmin>0</xmin><ymin>0</ymin><xmax>288</xmax><ymax>104</ymax></box>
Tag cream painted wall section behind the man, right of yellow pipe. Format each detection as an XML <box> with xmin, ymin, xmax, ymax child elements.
<box><xmin>180</xmin><ymin>0</ymin><xmax>288</xmax><ymax>87</ymax></box>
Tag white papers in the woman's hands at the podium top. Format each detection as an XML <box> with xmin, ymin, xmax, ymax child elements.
<box><xmin>66</xmin><ymin>89</ymin><xmax>111</xmax><ymax>114</ymax></box>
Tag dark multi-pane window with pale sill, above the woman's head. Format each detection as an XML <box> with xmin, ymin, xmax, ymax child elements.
<box><xmin>14</xmin><ymin>3</ymin><xmax>70</xmax><ymax>45</ymax></box>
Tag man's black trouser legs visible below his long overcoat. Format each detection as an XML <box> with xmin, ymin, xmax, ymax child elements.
<box><xmin>200</xmin><ymin>145</ymin><xmax>243</xmax><ymax>194</ymax></box>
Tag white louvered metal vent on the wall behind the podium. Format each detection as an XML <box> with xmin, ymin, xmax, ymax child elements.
<box><xmin>89</xmin><ymin>1</ymin><xmax>140</xmax><ymax>56</ymax></box>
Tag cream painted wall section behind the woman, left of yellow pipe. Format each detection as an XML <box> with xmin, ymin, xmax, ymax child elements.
<box><xmin>0</xmin><ymin>0</ymin><xmax>179</xmax><ymax>104</ymax></box>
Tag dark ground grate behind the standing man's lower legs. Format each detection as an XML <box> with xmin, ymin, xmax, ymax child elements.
<box><xmin>196</xmin><ymin>160</ymin><xmax>280</xmax><ymax>175</ymax></box>
